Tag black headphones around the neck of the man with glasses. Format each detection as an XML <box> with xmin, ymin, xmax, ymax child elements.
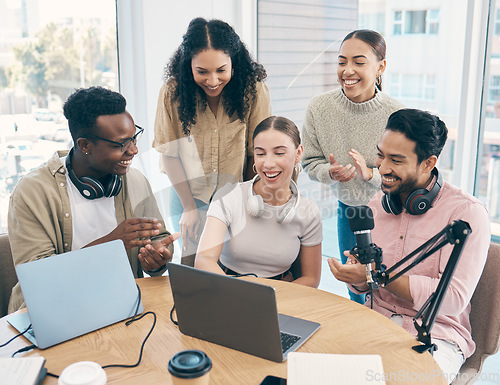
<box><xmin>66</xmin><ymin>148</ymin><xmax>122</xmax><ymax>199</ymax></box>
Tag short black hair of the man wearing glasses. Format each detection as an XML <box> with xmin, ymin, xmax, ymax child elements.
<box><xmin>63</xmin><ymin>87</ymin><xmax>127</xmax><ymax>143</ymax></box>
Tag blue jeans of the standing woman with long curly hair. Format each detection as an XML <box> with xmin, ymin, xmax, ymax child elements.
<box><xmin>169</xmin><ymin>187</ymin><xmax>208</xmax><ymax>266</ymax></box>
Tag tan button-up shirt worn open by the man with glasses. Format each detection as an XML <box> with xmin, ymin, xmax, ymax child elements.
<box><xmin>8</xmin><ymin>151</ymin><xmax>174</xmax><ymax>313</ymax></box>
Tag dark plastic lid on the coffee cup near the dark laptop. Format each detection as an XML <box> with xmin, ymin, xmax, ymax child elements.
<box><xmin>168</xmin><ymin>350</ymin><xmax>212</xmax><ymax>378</ymax></box>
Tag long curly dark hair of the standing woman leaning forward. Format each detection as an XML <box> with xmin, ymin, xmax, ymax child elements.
<box><xmin>164</xmin><ymin>17</ymin><xmax>267</xmax><ymax>136</ymax></box>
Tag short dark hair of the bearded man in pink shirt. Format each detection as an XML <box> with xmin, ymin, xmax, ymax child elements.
<box><xmin>386</xmin><ymin>108</ymin><xmax>448</xmax><ymax>164</ymax></box>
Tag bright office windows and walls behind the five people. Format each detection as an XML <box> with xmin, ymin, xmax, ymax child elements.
<box><xmin>0</xmin><ymin>0</ymin><xmax>500</xmax><ymax>249</ymax></box>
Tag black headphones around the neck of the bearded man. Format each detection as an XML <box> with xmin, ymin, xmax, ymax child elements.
<box><xmin>382</xmin><ymin>167</ymin><xmax>443</xmax><ymax>215</ymax></box>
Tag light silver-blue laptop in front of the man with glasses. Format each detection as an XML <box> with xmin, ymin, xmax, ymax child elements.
<box><xmin>7</xmin><ymin>240</ymin><xmax>144</xmax><ymax>349</ymax></box>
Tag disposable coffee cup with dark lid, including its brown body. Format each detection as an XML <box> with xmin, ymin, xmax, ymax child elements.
<box><xmin>168</xmin><ymin>350</ymin><xmax>212</xmax><ymax>385</ymax></box>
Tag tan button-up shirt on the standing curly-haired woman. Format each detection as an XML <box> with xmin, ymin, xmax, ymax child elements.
<box><xmin>153</xmin><ymin>79</ymin><xmax>271</xmax><ymax>203</ymax></box>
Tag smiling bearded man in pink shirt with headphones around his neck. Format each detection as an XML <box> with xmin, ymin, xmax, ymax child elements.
<box><xmin>328</xmin><ymin>109</ymin><xmax>490</xmax><ymax>381</ymax></box>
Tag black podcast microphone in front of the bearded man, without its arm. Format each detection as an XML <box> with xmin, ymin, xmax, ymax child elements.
<box><xmin>346</xmin><ymin>206</ymin><xmax>382</xmax><ymax>288</ymax></box>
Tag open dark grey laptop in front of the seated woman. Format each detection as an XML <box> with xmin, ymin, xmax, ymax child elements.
<box><xmin>168</xmin><ymin>263</ymin><xmax>320</xmax><ymax>362</ymax></box>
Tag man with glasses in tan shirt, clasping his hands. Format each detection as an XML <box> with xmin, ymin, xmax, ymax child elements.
<box><xmin>8</xmin><ymin>87</ymin><xmax>179</xmax><ymax>312</ymax></box>
